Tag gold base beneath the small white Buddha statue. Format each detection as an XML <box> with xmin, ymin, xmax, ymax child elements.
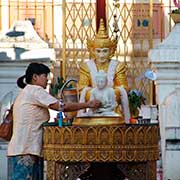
<box><xmin>72</xmin><ymin>116</ymin><xmax>125</xmax><ymax>126</ymax></box>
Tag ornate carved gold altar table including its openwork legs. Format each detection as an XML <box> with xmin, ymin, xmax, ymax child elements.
<box><xmin>43</xmin><ymin>124</ymin><xmax>159</xmax><ymax>180</ymax></box>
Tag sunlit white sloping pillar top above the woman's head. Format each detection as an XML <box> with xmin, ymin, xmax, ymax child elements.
<box><xmin>0</xmin><ymin>20</ymin><xmax>55</xmax><ymax>60</ymax></box>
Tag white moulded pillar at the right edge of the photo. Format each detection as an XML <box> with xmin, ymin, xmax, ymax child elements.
<box><xmin>149</xmin><ymin>24</ymin><xmax>180</xmax><ymax>180</ymax></box>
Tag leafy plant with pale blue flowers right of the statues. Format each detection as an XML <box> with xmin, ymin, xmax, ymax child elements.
<box><xmin>128</xmin><ymin>89</ymin><xmax>145</xmax><ymax>116</ymax></box>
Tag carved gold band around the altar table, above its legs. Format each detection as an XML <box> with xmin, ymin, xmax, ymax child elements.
<box><xmin>43</xmin><ymin>125</ymin><xmax>159</xmax><ymax>162</ymax></box>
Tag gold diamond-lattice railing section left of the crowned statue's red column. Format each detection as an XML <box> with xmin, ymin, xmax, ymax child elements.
<box><xmin>62</xmin><ymin>0</ymin><xmax>96</xmax><ymax>78</ymax></box>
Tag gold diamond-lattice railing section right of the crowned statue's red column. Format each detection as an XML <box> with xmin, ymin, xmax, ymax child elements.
<box><xmin>108</xmin><ymin>0</ymin><xmax>158</xmax><ymax>103</ymax></box>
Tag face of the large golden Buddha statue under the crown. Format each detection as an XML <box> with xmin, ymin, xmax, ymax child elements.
<box><xmin>95</xmin><ymin>48</ymin><xmax>110</xmax><ymax>64</ymax></box>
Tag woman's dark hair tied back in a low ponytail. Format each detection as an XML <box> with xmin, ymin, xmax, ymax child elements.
<box><xmin>17</xmin><ymin>63</ymin><xmax>50</xmax><ymax>88</ymax></box>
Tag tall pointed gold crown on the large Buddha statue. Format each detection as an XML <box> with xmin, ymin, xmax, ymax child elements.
<box><xmin>87</xmin><ymin>19</ymin><xmax>117</xmax><ymax>58</ymax></box>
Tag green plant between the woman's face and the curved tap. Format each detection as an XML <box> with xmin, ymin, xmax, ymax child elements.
<box><xmin>50</xmin><ymin>77</ymin><xmax>73</xmax><ymax>96</ymax></box>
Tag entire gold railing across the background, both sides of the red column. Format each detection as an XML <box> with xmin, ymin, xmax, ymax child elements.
<box><xmin>0</xmin><ymin>0</ymin><xmax>175</xmax><ymax>102</ymax></box>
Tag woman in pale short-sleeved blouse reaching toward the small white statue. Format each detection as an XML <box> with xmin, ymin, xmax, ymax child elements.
<box><xmin>8</xmin><ymin>63</ymin><xmax>100</xmax><ymax>180</ymax></box>
